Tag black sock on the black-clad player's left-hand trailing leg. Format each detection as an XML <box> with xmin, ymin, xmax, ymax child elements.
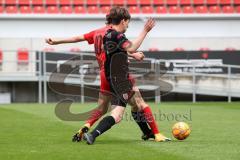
<box><xmin>91</xmin><ymin>116</ymin><xmax>115</xmax><ymax>138</ymax></box>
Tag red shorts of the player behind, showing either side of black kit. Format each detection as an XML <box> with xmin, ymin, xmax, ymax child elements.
<box><xmin>100</xmin><ymin>69</ymin><xmax>135</xmax><ymax>94</ymax></box>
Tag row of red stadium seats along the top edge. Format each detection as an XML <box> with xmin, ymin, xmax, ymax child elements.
<box><xmin>0</xmin><ymin>0</ymin><xmax>240</xmax><ymax>14</ymax></box>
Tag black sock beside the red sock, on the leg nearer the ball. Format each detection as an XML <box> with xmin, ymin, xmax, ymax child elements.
<box><xmin>132</xmin><ymin>112</ymin><xmax>152</xmax><ymax>135</ymax></box>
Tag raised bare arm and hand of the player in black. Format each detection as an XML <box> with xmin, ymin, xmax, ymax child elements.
<box><xmin>126</xmin><ymin>18</ymin><xmax>155</xmax><ymax>53</ymax></box>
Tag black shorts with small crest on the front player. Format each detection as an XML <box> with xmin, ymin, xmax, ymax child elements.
<box><xmin>109</xmin><ymin>78</ymin><xmax>134</xmax><ymax>107</ymax></box>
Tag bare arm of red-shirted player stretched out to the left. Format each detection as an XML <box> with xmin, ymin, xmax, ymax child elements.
<box><xmin>45</xmin><ymin>35</ymin><xmax>85</xmax><ymax>45</ymax></box>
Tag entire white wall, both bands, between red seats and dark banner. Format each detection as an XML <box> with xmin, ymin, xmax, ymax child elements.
<box><xmin>0</xmin><ymin>15</ymin><xmax>240</xmax><ymax>50</ymax></box>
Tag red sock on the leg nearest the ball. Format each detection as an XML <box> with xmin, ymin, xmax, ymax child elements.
<box><xmin>143</xmin><ymin>106</ymin><xmax>159</xmax><ymax>134</ymax></box>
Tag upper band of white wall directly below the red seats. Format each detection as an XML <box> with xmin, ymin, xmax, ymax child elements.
<box><xmin>0</xmin><ymin>16</ymin><xmax>240</xmax><ymax>38</ymax></box>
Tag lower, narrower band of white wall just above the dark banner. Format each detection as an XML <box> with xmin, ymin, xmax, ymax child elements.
<box><xmin>0</xmin><ymin>38</ymin><xmax>240</xmax><ymax>51</ymax></box>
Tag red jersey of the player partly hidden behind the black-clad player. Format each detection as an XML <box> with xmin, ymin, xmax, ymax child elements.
<box><xmin>83</xmin><ymin>26</ymin><xmax>111</xmax><ymax>70</ymax></box>
